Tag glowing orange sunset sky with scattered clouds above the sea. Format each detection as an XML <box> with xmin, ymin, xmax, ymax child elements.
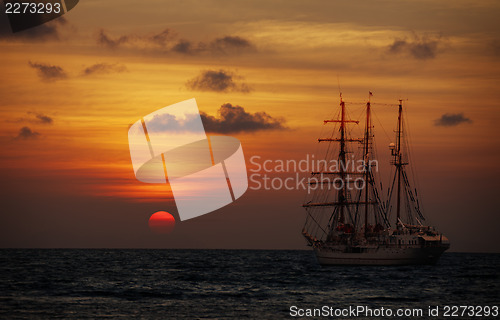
<box><xmin>0</xmin><ymin>0</ymin><xmax>500</xmax><ymax>252</ymax></box>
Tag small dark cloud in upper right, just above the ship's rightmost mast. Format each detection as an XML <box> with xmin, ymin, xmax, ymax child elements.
<box><xmin>388</xmin><ymin>35</ymin><xmax>440</xmax><ymax>60</ymax></box>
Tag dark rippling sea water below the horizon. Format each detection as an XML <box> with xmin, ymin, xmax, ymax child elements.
<box><xmin>0</xmin><ymin>249</ymin><xmax>500</xmax><ymax>319</ymax></box>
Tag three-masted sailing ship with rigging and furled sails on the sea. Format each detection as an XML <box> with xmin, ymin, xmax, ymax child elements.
<box><xmin>302</xmin><ymin>92</ymin><xmax>450</xmax><ymax>265</ymax></box>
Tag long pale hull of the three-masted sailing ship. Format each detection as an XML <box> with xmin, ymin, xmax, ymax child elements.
<box><xmin>314</xmin><ymin>245</ymin><xmax>449</xmax><ymax>266</ymax></box>
